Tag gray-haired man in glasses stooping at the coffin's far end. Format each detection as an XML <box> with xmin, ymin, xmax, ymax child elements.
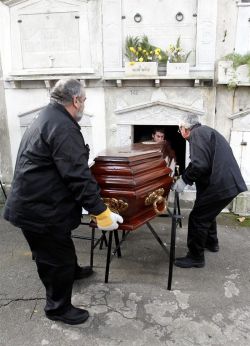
<box><xmin>173</xmin><ymin>115</ymin><xmax>247</xmax><ymax>268</ymax></box>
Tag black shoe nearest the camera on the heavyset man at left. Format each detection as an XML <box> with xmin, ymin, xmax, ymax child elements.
<box><xmin>46</xmin><ymin>306</ymin><xmax>89</xmax><ymax>324</ymax></box>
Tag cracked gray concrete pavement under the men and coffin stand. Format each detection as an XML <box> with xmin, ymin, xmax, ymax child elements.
<box><xmin>0</xmin><ymin>205</ymin><xmax>250</xmax><ymax>346</ymax></box>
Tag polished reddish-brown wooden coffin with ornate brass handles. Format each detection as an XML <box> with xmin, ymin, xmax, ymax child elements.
<box><xmin>91</xmin><ymin>144</ymin><xmax>173</xmax><ymax>230</ymax></box>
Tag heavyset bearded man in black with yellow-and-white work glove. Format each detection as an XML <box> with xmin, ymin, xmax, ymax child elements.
<box><xmin>4</xmin><ymin>79</ymin><xmax>123</xmax><ymax>324</ymax></box>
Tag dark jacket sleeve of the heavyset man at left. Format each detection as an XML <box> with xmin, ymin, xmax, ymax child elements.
<box><xmin>50</xmin><ymin>127</ymin><xmax>106</xmax><ymax>215</ymax></box>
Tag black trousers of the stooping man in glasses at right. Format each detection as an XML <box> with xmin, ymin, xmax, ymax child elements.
<box><xmin>187</xmin><ymin>198</ymin><xmax>233</xmax><ymax>259</ymax></box>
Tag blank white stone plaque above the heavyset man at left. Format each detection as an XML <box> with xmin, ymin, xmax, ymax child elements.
<box><xmin>19</xmin><ymin>12</ymin><xmax>80</xmax><ymax>69</ymax></box>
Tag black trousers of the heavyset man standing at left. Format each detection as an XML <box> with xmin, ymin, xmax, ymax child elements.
<box><xmin>22</xmin><ymin>228</ymin><xmax>77</xmax><ymax>314</ymax></box>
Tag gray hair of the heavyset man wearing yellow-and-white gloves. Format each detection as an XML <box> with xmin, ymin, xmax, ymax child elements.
<box><xmin>50</xmin><ymin>79</ymin><xmax>84</xmax><ymax>105</ymax></box>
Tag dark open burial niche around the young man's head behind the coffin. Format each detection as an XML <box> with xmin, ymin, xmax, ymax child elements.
<box><xmin>133</xmin><ymin>125</ymin><xmax>186</xmax><ymax>173</ymax></box>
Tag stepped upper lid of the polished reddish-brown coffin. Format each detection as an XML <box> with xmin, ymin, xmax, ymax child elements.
<box><xmin>91</xmin><ymin>143</ymin><xmax>172</xmax><ymax>192</ymax></box>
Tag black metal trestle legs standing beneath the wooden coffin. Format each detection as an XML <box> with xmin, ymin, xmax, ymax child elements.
<box><xmin>72</xmin><ymin>191</ymin><xmax>182</xmax><ymax>290</ymax></box>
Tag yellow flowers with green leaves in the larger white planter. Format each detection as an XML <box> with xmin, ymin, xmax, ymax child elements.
<box><xmin>125</xmin><ymin>35</ymin><xmax>166</xmax><ymax>65</ymax></box>
